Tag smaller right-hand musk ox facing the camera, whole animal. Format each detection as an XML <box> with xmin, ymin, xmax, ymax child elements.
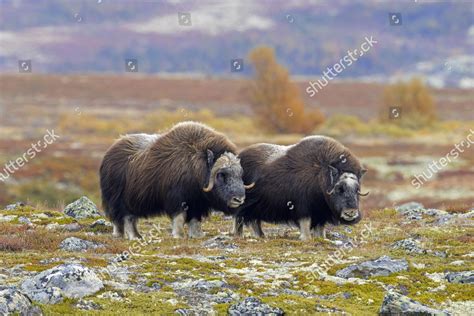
<box><xmin>234</xmin><ymin>136</ymin><xmax>368</xmax><ymax>240</ymax></box>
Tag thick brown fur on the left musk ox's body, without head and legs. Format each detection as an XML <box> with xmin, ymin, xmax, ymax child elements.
<box><xmin>100</xmin><ymin>122</ymin><xmax>236</xmax><ymax>223</ymax></box>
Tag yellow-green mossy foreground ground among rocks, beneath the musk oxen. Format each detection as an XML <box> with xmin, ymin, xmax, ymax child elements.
<box><xmin>0</xmin><ymin>207</ymin><xmax>474</xmax><ymax>315</ymax></box>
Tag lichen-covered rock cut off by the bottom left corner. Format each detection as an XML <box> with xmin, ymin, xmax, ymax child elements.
<box><xmin>0</xmin><ymin>286</ymin><xmax>42</xmax><ymax>316</ymax></box>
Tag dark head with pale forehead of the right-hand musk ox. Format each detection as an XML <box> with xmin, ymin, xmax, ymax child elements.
<box><xmin>325</xmin><ymin>165</ymin><xmax>369</xmax><ymax>224</ymax></box>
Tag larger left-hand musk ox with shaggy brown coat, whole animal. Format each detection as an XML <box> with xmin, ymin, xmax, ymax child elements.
<box><xmin>100</xmin><ymin>122</ymin><xmax>252</xmax><ymax>239</ymax></box>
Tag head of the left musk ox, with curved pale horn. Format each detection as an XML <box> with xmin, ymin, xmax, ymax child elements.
<box><xmin>203</xmin><ymin>150</ymin><xmax>255</xmax><ymax>208</ymax></box>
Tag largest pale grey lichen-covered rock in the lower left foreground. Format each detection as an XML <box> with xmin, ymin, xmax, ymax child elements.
<box><xmin>21</xmin><ymin>264</ymin><xmax>104</xmax><ymax>304</ymax></box>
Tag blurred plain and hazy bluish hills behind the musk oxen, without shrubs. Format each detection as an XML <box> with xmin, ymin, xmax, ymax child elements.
<box><xmin>0</xmin><ymin>0</ymin><xmax>474</xmax><ymax>209</ymax></box>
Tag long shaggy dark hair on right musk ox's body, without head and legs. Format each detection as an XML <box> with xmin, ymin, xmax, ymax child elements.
<box><xmin>237</xmin><ymin>136</ymin><xmax>364</xmax><ymax>228</ymax></box>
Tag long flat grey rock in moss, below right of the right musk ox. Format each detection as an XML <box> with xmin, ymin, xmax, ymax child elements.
<box><xmin>336</xmin><ymin>256</ymin><xmax>408</xmax><ymax>278</ymax></box>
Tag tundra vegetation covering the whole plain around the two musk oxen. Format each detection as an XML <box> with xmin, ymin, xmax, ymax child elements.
<box><xmin>0</xmin><ymin>74</ymin><xmax>474</xmax><ymax>315</ymax></box>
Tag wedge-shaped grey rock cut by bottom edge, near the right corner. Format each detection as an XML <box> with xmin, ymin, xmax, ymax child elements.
<box><xmin>380</xmin><ymin>291</ymin><xmax>449</xmax><ymax>316</ymax></box>
